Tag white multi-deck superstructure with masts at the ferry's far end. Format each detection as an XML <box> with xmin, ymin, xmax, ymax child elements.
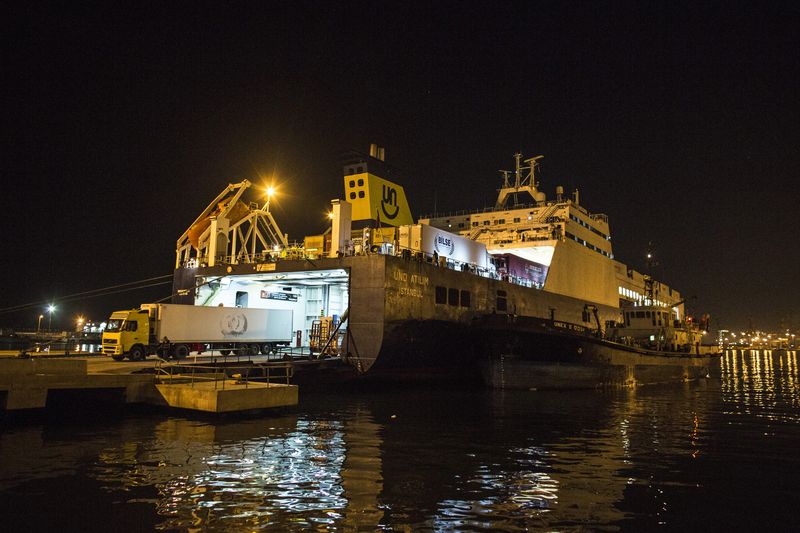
<box><xmin>420</xmin><ymin>154</ymin><xmax>682</xmax><ymax>313</ymax></box>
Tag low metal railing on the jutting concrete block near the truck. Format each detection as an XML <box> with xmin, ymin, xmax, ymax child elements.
<box><xmin>154</xmin><ymin>358</ymin><xmax>294</xmax><ymax>390</ymax></box>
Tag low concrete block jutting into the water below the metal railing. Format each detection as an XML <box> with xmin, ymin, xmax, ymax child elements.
<box><xmin>156</xmin><ymin>379</ymin><xmax>298</xmax><ymax>413</ymax></box>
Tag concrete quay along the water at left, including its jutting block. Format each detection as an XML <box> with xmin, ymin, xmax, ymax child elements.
<box><xmin>0</xmin><ymin>357</ymin><xmax>298</xmax><ymax>413</ymax></box>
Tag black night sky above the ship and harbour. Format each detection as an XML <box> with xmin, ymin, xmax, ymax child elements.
<box><xmin>0</xmin><ymin>1</ymin><xmax>800</xmax><ymax>330</ymax></box>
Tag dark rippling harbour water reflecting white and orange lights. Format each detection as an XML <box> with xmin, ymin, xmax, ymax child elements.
<box><xmin>0</xmin><ymin>352</ymin><xmax>800</xmax><ymax>531</ymax></box>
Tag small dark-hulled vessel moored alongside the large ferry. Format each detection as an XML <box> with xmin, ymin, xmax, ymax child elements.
<box><xmin>478</xmin><ymin>306</ymin><xmax>719</xmax><ymax>390</ymax></box>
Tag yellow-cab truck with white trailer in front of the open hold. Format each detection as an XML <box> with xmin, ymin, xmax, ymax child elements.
<box><xmin>102</xmin><ymin>303</ymin><xmax>293</xmax><ymax>361</ymax></box>
